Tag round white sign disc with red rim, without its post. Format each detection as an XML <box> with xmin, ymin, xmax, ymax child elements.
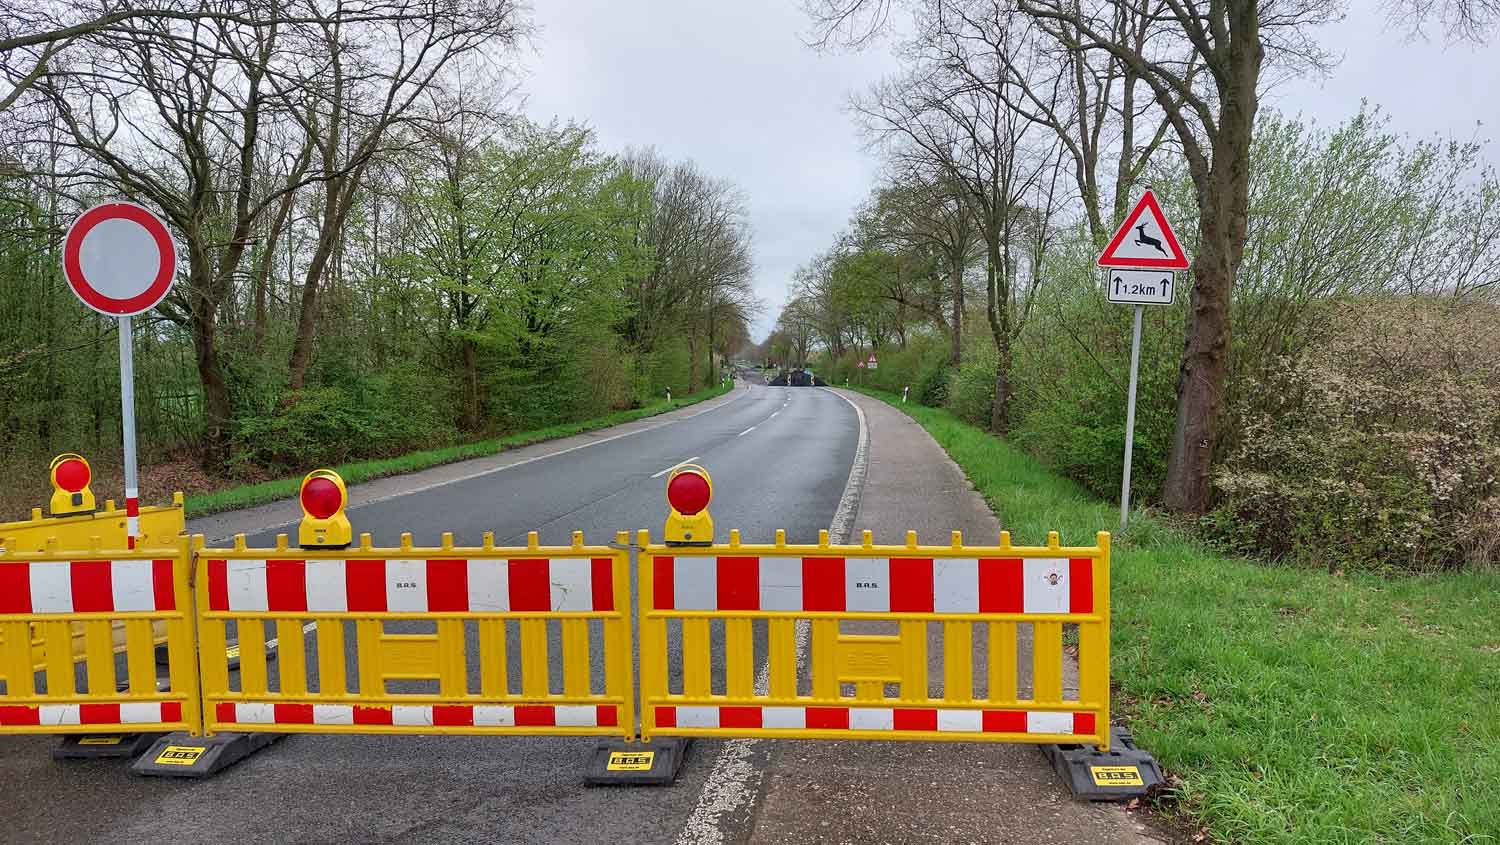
<box><xmin>63</xmin><ymin>203</ymin><xmax>177</xmax><ymax>317</ymax></box>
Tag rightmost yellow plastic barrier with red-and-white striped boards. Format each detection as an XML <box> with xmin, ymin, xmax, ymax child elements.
<box><xmin>638</xmin><ymin>531</ymin><xmax>1110</xmax><ymax>750</ymax></box>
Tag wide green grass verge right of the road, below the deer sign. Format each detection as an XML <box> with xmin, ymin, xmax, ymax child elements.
<box><xmin>872</xmin><ymin>392</ymin><xmax>1500</xmax><ymax>843</ymax></box>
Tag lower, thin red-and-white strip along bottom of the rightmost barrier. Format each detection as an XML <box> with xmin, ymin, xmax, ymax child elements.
<box><xmin>654</xmin><ymin>705</ymin><xmax>1095</xmax><ymax>737</ymax></box>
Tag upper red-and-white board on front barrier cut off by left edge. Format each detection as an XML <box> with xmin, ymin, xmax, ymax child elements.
<box><xmin>0</xmin><ymin>560</ymin><xmax>177</xmax><ymax>614</ymax></box>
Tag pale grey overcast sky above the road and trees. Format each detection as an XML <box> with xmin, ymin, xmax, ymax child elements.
<box><xmin>522</xmin><ymin>0</ymin><xmax>1500</xmax><ymax>339</ymax></box>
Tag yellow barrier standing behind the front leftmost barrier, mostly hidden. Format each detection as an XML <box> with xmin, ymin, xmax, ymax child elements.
<box><xmin>0</xmin><ymin>492</ymin><xmax>186</xmax><ymax>671</ymax></box>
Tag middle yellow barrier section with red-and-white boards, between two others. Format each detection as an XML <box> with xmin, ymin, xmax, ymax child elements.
<box><xmin>194</xmin><ymin>531</ymin><xmax>635</xmax><ymax>737</ymax></box>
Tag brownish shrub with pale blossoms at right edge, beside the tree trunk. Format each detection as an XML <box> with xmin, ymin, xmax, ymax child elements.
<box><xmin>1205</xmin><ymin>300</ymin><xmax>1500</xmax><ymax>572</ymax></box>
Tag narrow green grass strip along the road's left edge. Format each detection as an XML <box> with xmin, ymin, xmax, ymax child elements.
<box><xmin>185</xmin><ymin>386</ymin><xmax>731</xmax><ymax>518</ymax></box>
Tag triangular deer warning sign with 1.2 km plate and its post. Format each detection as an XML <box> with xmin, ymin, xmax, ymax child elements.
<box><xmin>1098</xmin><ymin>185</ymin><xmax>1188</xmax><ymax>531</ymax></box>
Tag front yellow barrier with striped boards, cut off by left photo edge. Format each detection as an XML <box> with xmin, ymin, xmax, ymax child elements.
<box><xmin>0</xmin><ymin>537</ymin><xmax>203</xmax><ymax>734</ymax></box>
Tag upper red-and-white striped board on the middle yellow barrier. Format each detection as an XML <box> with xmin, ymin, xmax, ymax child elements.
<box><xmin>209</xmin><ymin>557</ymin><xmax>615</xmax><ymax>614</ymax></box>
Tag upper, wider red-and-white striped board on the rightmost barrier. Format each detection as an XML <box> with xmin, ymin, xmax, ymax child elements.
<box><xmin>651</xmin><ymin>557</ymin><xmax>1094</xmax><ymax>614</ymax></box>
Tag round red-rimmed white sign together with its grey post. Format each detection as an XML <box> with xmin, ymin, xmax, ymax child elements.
<box><xmin>63</xmin><ymin>203</ymin><xmax>177</xmax><ymax>549</ymax></box>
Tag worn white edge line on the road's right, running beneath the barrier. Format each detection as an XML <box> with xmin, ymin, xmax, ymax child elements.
<box><xmin>677</xmin><ymin>389</ymin><xmax>870</xmax><ymax>845</ymax></box>
